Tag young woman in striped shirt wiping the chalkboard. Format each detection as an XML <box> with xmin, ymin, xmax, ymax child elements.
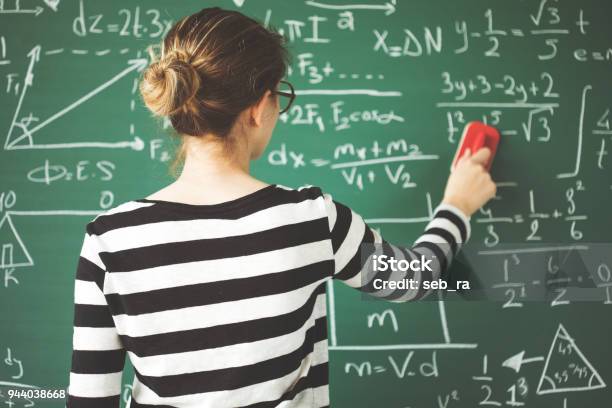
<box><xmin>67</xmin><ymin>7</ymin><xmax>495</xmax><ymax>408</ymax></box>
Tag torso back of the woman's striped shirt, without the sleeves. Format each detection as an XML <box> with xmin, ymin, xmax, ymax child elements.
<box><xmin>77</xmin><ymin>185</ymin><xmax>334</xmax><ymax>407</ymax></box>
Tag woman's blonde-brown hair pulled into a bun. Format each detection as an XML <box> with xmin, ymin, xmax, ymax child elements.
<box><xmin>139</xmin><ymin>7</ymin><xmax>290</xmax><ymax>175</ymax></box>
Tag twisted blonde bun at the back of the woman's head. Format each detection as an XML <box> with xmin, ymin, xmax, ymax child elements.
<box><xmin>140</xmin><ymin>52</ymin><xmax>201</xmax><ymax>116</ymax></box>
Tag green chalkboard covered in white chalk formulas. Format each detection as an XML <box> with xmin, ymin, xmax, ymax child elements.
<box><xmin>0</xmin><ymin>0</ymin><xmax>612</xmax><ymax>408</ymax></box>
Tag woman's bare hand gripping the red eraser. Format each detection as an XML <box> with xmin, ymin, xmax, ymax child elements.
<box><xmin>442</xmin><ymin>147</ymin><xmax>497</xmax><ymax>217</ymax></box>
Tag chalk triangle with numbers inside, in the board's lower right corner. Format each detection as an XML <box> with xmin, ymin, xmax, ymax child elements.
<box><xmin>536</xmin><ymin>324</ymin><xmax>606</xmax><ymax>395</ymax></box>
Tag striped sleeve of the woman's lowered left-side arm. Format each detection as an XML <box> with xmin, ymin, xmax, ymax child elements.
<box><xmin>66</xmin><ymin>228</ymin><xmax>126</xmax><ymax>408</ymax></box>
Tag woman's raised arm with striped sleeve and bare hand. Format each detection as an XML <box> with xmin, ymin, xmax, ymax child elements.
<box><xmin>324</xmin><ymin>149</ymin><xmax>496</xmax><ymax>302</ymax></box>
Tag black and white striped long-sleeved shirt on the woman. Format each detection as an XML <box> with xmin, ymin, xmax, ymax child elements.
<box><xmin>66</xmin><ymin>185</ymin><xmax>470</xmax><ymax>408</ymax></box>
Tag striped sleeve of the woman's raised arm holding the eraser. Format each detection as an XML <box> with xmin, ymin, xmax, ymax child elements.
<box><xmin>324</xmin><ymin>194</ymin><xmax>471</xmax><ymax>302</ymax></box>
